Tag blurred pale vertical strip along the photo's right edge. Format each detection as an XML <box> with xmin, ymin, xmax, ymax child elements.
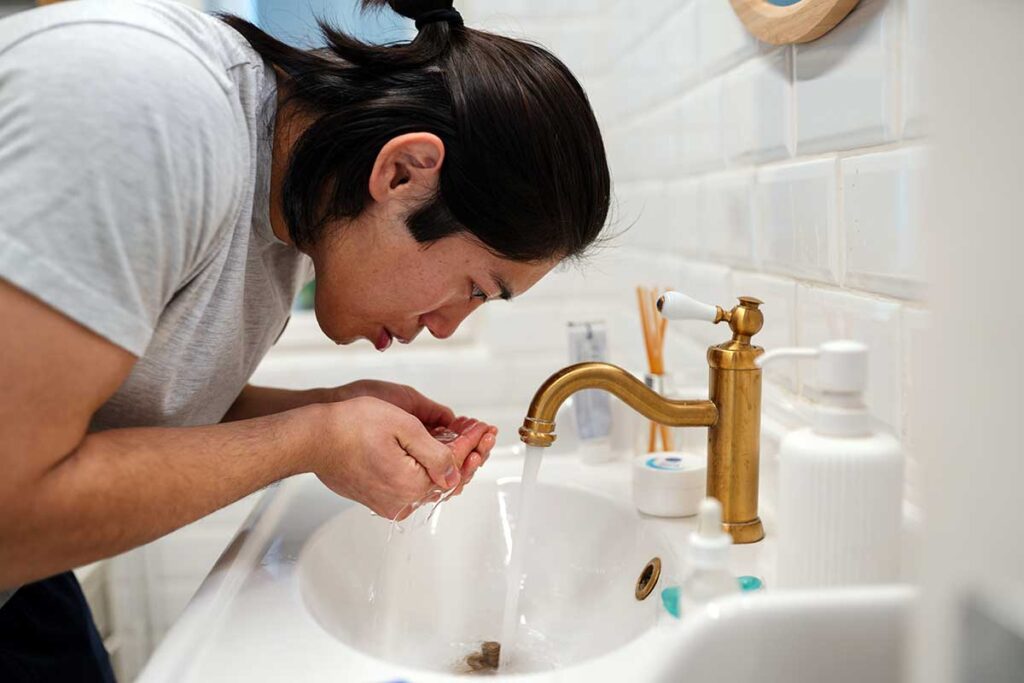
<box><xmin>912</xmin><ymin>0</ymin><xmax>1024</xmax><ymax>683</ymax></box>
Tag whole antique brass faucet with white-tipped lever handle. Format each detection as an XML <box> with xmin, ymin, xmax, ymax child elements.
<box><xmin>519</xmin><ymin>292</ymin><xmax>765</xmax><ymax>543</ymax></box>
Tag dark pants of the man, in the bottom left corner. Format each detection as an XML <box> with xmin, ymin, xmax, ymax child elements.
<box><xmin>0</xmin><ymin>571</ymin><xmax>114</xmax><ymax>683</ymax></box>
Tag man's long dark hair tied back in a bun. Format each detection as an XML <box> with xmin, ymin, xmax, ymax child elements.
<box><xmin>221</xmin><ymin>0</ymin><xmax>610</xmax><ymax>261</ymax></box>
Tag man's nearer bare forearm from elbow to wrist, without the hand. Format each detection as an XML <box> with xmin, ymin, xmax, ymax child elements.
<box><xmin>0</xmin><ymin>409</ymin><xmax>318</xmax><ymax>588</ymax></box>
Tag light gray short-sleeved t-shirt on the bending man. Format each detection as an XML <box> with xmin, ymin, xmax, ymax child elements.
<box><xmin>0</xmin><ymin>0</ymin><xmax>312</xmax><ymax>602</ymax></box>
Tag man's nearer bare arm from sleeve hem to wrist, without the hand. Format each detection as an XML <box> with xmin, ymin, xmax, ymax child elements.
<box><xmin>0</xmin><ymin>281</ymin><xmax>323</xmax><ymax>587</ymax></box>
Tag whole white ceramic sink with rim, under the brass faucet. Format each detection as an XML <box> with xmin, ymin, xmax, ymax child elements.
<box><xmin>139</xmin><ymin>447</ymin><xmax>911</xmax><ymax>683</ymax></box>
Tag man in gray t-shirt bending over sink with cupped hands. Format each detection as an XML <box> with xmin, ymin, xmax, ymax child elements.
<box><xmin>0</xmin><ymin>0</ymin><xmax>610</xmax><ymax>682</ymax></box>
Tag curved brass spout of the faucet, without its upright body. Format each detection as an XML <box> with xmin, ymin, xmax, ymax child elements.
<box><xmin>519</xmin><ymin>362</ymin><xmax>718</xmax><ymax>446</ymax></box>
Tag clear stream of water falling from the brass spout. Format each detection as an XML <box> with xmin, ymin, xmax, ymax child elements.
<box><xmin>499</xmin><ymin>445</ymin><xmax>544</xmax><ymax>670</ymax></box>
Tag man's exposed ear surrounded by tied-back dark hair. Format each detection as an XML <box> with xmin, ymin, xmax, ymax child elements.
<box><xmin>370</xmin><ymin>133</ymin><xmax>444</xmax><ymax>203</ymax></box>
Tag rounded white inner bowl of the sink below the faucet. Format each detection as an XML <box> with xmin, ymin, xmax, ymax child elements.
<box><xmin>297</xmin><ymin>477</ymin><xmax>676</xmax><ymax>673</ymax></box>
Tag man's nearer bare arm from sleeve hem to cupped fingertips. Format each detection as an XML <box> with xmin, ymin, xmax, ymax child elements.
<box><xmin>0</xmin><ymin>280</ymin><xmax>494</xmax><ymax>588</ymax></box>
